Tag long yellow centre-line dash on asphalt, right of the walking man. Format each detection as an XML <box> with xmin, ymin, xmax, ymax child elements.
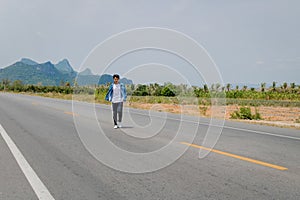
<box><xmin>181</xmin><ymin>142</ymin><xmax>288</xmax><ymax>170</ymax></box>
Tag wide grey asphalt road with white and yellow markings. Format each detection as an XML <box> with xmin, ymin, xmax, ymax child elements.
<box><xmin>0</xmin><ymin>93</ymin><xmax>300</xmax><ymax>200</ymax></box>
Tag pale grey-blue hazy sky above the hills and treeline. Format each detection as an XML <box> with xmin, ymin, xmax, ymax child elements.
<box><xmin>0</xmin><ymin>0</ymin><xmax>300</xmax><ymax>84</ymax></box>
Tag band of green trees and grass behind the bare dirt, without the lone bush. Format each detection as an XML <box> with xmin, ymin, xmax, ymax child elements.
<box><xmin>0</xmin><ymin>79</ymin><xmax>300</xmax><ymax>104</ymax></box>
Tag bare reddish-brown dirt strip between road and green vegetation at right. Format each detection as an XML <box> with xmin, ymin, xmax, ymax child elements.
<box><xmin>127</xmin><ymin>102</ymin><xmax>300</xmax><ymax>129</ymax></box>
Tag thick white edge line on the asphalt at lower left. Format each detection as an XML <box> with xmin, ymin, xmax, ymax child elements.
<box><xmin>0</xmin><ymin>124</ymin><xmax>54</xmax><ymax>200</ymax></box>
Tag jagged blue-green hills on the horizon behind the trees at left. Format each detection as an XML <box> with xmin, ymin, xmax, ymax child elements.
<box><xmin>0</xmin><ymin>58</ymin><xmax>132</xmax><ymax>86</ymax></box>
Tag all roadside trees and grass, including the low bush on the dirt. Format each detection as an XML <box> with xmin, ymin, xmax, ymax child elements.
<box><xmin>0</xmin><ymin>79</ymin><xmax>300</xmax><ymax>123</ymax></box>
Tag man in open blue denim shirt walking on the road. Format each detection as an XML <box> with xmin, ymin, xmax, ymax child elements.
<box><xmin>105</xmin><ymin>74</ymin><xmax>127</xmax><ymax>129</ymax></box>
